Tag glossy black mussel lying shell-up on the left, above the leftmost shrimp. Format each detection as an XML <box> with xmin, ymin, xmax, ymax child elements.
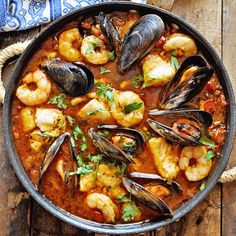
<box><xmin>41</xmin><ymin>58</ymin><xmax>94</xmax><ymax>97</ymax></box>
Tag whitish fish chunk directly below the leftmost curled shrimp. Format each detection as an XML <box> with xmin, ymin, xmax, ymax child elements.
<box><xmin>35</xmin><ymin>108</ymin><xmax>66</xmax><ymax>137</ymax></box>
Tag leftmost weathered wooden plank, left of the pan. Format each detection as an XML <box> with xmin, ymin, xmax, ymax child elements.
<box><xmin>0</xmin><ymin>29</ymin><xmax>37</xmax><ymax>236</ymax></box>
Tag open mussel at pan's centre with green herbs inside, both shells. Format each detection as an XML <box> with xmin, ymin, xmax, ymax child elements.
<box><xmin>89</xmin><ymin>125</ymin><xmax>145</xmax><ymax>163</ymax></box>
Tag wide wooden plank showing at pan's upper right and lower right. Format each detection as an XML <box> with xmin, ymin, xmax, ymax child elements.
<box><xmin>146</xmin><ymin>0</ymin><xmax>221</xmax><ymax>236</ymax></box>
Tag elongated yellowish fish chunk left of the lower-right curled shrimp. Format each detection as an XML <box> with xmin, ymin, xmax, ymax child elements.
<box><xmin>148</xmin><ymin>138</ymin><xmax>179</xmax><ymax>180</ymax></box>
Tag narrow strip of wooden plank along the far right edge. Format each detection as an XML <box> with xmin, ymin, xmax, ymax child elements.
<box><xmin>222</xmin><ymin>0</ymin><xmax>236</xmax><ymax>235</ymax></box>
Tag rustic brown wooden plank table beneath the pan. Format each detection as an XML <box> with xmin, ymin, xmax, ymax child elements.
<box><xmin>0</xmin><ymin>0</ymin><xmax>236</xmax><ymax>236</ymax></box>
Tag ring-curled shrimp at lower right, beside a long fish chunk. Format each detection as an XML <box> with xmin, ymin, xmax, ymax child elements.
<box><xmin>179</xmin><ymin>146</ymin><xmax>212</xmax><ymax>181</ymax></box>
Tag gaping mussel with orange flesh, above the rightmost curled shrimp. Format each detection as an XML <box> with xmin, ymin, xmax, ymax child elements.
<box><xmin>147</xmin><ymin>109</ymin><xmax>212</xmax><ymax>145</ymax></box>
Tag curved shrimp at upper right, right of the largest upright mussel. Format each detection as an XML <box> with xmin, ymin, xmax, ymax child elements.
<box><xmin>163</xmin><ymin>33</ymin><xmax>197</xmax><ymax>57</ymax></box>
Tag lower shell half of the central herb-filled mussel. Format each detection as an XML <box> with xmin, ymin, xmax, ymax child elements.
<box><xmin>88</xmin><ymin>128</ymin><xmax>133</xmax><ymax>164</ymax></box>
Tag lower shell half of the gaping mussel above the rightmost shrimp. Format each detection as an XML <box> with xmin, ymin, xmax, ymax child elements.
<box><xmin>147</xmin><ymin>118</ymin><xmax>200</xmax><ymax>145</ymax></box>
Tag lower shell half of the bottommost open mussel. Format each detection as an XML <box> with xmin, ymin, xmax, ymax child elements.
<box><xmin>123</xmin><ymin>177</ymin><xmax>173</xmax><ymax>216</ymax></box>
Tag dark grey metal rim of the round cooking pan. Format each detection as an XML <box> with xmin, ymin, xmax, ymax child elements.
<box><xmin>3</xmin><ymin>2</ymin><xmax>235</xmax><ymax>235</ymax></box>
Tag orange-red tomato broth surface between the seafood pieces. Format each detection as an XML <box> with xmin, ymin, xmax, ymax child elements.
<box><xmin>12</xmin><ymin>12</ymin><xmax>226</xmax><ymax>223</ymax></box>
